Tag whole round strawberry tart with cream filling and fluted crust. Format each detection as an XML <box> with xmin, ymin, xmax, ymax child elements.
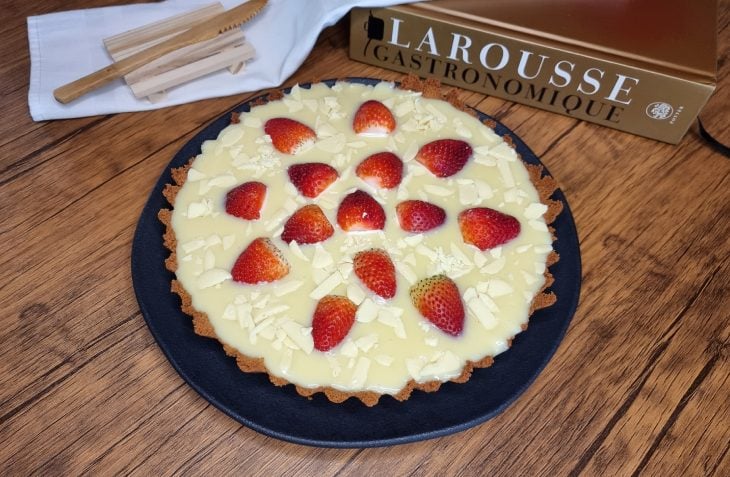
<box><xmin>159</xmin><ymin>78</ymin><xmax>561</xmax><ymax>405</ymax></box>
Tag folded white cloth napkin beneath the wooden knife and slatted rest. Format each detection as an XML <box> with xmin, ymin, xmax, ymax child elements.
<box><xmin>28</xmin><ymin>0</ymin><xmax>424</xmax><ymax>121</ymax></box>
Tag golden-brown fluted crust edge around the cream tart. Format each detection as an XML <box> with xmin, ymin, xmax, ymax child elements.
<box><xmin>157</xmin><ymin>75</ymin><xmax>563</xmax><ymax>407</ymax></box>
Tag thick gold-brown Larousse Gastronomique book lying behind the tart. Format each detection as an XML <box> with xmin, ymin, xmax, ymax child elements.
<box><xmin>350</xmin><ymin>0</ymin><xmax>717</xmax><ymax>144</ymax></box>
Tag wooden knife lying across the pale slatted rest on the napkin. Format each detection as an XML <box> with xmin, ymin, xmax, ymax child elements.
<box><xmin>53</xmin><ymin>0</ymin><xmax>267</xmax><ymax>104</ymax></box>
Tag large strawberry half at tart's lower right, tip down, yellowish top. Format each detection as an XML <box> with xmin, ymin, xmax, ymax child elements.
<box><xmin>411</xmin><ymin>275</ymin><xmax>464</xmax><ymax>336</ymax></box>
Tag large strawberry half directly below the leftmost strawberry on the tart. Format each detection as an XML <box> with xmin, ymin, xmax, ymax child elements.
<box><xmin>231</xmin><ymin>237</ymin><xmax>289</xmax><ymax>284</ymax></box>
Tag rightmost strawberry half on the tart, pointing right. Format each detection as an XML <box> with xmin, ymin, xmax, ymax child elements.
<box><xmin>459</xmin><ymin>207</ymin><xmax>520</xmax><ymax>250</ymax></box>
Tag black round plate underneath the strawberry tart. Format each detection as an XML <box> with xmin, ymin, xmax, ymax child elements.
<box><xmin>132</xmin><ymin>78</ymin><xmax>581</xmax><ymax>447</ymax></box>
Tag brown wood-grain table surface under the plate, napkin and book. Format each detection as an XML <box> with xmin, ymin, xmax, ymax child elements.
<box><xmin>0</xmin><ymin>0</ymin><xmax>730</xmax><ymax>476</ymax></box>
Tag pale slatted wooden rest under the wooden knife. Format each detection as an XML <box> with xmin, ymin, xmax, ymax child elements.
<box><xmin>104</xmin><ymin>3</ymin><xmax>255</xmax><ymax>103</ymax></box>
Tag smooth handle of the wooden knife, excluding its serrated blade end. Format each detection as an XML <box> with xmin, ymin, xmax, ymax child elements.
<box><xmin>53</xmin><ymin>31</ymin><xmax>217</xmax><ymax>104</ymax></box>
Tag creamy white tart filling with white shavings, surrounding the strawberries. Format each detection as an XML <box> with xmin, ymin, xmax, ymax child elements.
<box><xmin>172</xmin><ymin>83</ymin><xmax>552</xmax><ymax>394</ymax></box>
